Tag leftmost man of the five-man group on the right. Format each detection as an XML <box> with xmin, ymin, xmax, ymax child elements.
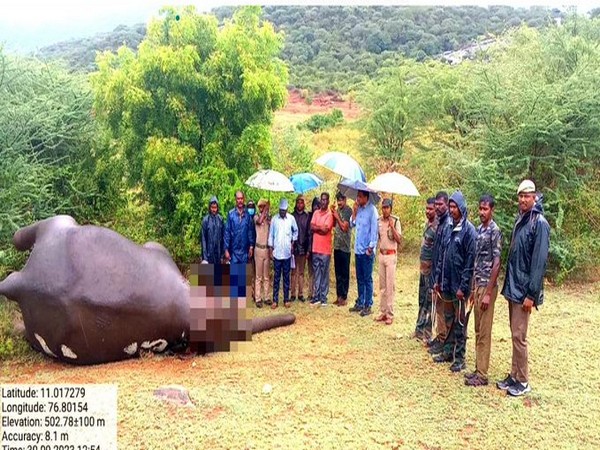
<box><xmin>415</xmin><ymin>197</ymin><xmax>438</xmax><ymax>341</ymax></box>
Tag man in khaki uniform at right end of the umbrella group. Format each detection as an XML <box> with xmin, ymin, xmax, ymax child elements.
<box><xmin>375</xmin><ymin>198</ymin><xmax>402</xmax><ymax>325</ymax></box>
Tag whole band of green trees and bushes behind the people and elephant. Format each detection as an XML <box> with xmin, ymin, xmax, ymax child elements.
<box><xmin>0</xmin><ymin>7</ymin><xmax>600</xmax><ymax>281</ymax></box>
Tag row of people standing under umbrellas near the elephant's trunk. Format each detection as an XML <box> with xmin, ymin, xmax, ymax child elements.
<box><xmin>202</xmin><ymin>191</ymin><xmax>402</xmax><ymax>325</ymax></box>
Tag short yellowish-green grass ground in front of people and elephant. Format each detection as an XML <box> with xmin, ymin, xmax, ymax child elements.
<box><xmin>0</xmin><ymin>254</ymin><xmax>600</xmax><ymax>450</ymax></box>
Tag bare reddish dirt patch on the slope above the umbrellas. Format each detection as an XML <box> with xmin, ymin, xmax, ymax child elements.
<box><xmin>282</xmin><ymin>89</ymin><xmax>360</xmax><ymax>120</ymax></box>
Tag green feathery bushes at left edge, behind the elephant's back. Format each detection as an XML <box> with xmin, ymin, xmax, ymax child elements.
<box><xmin>0</xmin><ymin>51</ymin><xmax>99</xmax><ymax>273</ymax></box>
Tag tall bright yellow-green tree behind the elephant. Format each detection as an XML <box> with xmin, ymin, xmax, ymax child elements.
<box><xmin>92</xmin><ymin>7</ymin><xmax>287</xmax><ymax>261</ymax></box>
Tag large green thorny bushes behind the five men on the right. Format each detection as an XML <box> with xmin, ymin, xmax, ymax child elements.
<box><xmin>362</xmin><ymin>16</ymin><xmax>600</xmax><ymax>282</ymax></box>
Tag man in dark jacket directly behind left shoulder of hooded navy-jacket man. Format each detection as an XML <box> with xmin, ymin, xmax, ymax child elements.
<box><xmin>427</xmin><ymin>191</ymin><xmax>453</xmax><ymax>355</ymax></box>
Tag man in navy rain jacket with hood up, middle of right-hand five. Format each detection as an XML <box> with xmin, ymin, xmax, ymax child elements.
<box><xmin>433</xmin><ymin>191</ymin><xmax>477</xmax><ymax>372</ymax></box>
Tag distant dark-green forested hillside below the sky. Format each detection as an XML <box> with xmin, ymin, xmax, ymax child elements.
<box><xmin>39</xmin><ymin>6</ymin><xmax>564</xmax><ymax>93</ymax></box>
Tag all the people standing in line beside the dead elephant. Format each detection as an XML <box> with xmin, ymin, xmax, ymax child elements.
<box><xmin>202</xmin><ymin>180</ymin><xmax>550</xmax><ymax>396</ymax></box>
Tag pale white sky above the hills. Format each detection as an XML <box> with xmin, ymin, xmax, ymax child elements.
<box><xmin>0</xmin><ymin>0</ymin><xmax>600</xmax><ymax>50</ymax></box>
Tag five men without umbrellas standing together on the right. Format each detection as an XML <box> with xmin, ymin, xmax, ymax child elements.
<box><xmin>415</xmin><ymin>180</ymin><xmax>550</xmax><ymax>396</ymax></box>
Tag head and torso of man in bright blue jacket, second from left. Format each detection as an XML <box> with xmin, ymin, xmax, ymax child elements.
<box><xmin>224</xmin><ymin>191</ymin><xmax>254</xmax><ymax>264</ymax></box>
